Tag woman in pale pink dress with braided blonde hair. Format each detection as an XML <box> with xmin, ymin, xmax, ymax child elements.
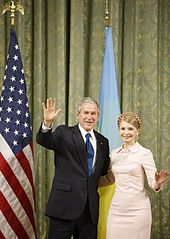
<box><xmin>100</xmin><ymin>112</ymin><xmax>168</xmax><ymax>239</ymax></box>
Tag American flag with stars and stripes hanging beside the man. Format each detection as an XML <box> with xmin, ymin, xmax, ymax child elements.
<box><xmin>0</xmin><ymin>28</ymin><xmax>36</xmax><ymax>239</ymax></box>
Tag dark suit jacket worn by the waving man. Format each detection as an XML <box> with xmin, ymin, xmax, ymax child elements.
<box><xmin>37</xmin><ymin>125</ymin><xmax>110</xmax><ymax>224</ymax></box>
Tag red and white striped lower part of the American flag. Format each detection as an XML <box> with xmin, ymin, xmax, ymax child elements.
<box><xmin>0</xmin><ymin>134</ymin><xmax>36</xmax><ymax>239</ymax></box>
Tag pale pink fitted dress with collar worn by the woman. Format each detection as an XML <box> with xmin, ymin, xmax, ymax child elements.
<box><xmin>106</xmin><ymin>143</ymin><xmax>159</xmax><ymax>239</ymax></box>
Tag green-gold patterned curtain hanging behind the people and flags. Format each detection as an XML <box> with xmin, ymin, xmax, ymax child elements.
<box><xmin>0</xmin><ymin>0</ymin><xmax>170</xmax><ymax>239</ymax></box>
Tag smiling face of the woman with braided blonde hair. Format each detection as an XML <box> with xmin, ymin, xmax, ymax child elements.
<box><xmin>119</xmin><ymin>121</ymin><xmax>139</xmax><ymax>145</ymax></box>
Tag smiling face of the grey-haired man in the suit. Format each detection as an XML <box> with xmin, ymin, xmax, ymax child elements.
<box><xmin>77</xmin><ymin>102</ymin><xmax>99</xmax><ymax>131</ymax></box>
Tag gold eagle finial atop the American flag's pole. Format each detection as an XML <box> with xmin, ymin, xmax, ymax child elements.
<box><xmin>2</xmin><ymin>1</ymin><xmax>24</xmax><ymax>26</ymax></box>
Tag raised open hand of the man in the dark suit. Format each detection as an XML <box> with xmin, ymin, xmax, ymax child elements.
<box><xmin>42</xmin><ymin>97</ymin><xmax>61</xmax><ymax>127</ymax></box>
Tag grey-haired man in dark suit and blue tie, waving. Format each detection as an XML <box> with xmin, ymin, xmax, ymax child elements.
<box><xmin>37</xmin><ymin>97</ymin><xmax>110</xmax><ymax>239</ymax></box>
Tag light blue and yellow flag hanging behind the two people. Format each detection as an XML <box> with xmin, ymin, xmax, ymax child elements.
<box><xmin>98</xmin><ymin>27</ymin><xmax>122</xmax><ymax>239</ymax></box>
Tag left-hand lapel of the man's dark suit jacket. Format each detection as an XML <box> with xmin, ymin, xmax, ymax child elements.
<box><xmin>73</xmin><ymin>125</ymin><xmax>88</xmax><ymax>173</ymax></box>
